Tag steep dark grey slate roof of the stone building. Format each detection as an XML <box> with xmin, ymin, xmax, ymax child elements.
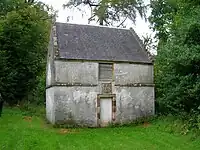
<box><xmin>55</xmin><ymin>22</ymin><xmax>151</xmax><ymax>63</ymax></box>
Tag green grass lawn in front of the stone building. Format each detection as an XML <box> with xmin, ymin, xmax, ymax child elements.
<box><xmin>0</xmin><ymin>109</ymin><xmax>200</xmax><ymax>150</ymax></box>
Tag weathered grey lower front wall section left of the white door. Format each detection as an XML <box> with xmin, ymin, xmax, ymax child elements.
<box><xmin>49</xmin><ymin>86</ymin><xmax>98</xmax><ymax>126</ymax></box>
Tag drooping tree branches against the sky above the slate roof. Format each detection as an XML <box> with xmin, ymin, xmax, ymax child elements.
<box><xmin>64</xmin><ymin>0</ymin><xmax>146</xmax><ymax>27</ymax></box>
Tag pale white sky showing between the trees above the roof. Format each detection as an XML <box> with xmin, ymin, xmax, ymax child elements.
<box><xmin>40</xmin><ymin>0</ymin><xmax>152</xmax><ymax>37</ymax></box>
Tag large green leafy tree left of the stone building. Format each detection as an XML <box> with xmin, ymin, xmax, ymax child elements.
<box><xmin>0</xmin><ymin>0</ymin><xmax>51</xmax><ymax>104</ymax></box>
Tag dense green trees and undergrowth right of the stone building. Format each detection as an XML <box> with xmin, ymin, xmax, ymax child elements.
<box><xmin>150</xmin><ymin>0</ymin><xmax>200</xmax><ymax>132</ymax></box>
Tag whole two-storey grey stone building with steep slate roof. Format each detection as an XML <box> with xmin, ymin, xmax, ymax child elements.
<box><xmin>46</xmin><ymin>22</ymin><xmax>154</xmax><ymax>127</ymax></box>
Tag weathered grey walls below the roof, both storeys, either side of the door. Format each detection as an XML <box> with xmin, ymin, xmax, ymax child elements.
<box><xmin>47</xmin><ymin>60</ymin><xmax>154</xmax><ymax>126</ymax></box>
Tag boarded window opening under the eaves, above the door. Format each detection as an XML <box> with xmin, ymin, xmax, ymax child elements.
<box><xmin>99</xmin><ymin>63</ymin><xmax>113</xmax><ymax>81</ymax></box>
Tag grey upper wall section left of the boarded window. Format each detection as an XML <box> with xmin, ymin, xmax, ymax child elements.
<box><xmin>55</xmin><ymin>61</ymin><xmax>98</xmax><ymax>85</ymax></box>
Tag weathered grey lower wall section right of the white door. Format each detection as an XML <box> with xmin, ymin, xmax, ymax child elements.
<box><xmin>115</xmin><ymin>86</ymin><xmax>154</xmax><ymax>123</ymax></box>
